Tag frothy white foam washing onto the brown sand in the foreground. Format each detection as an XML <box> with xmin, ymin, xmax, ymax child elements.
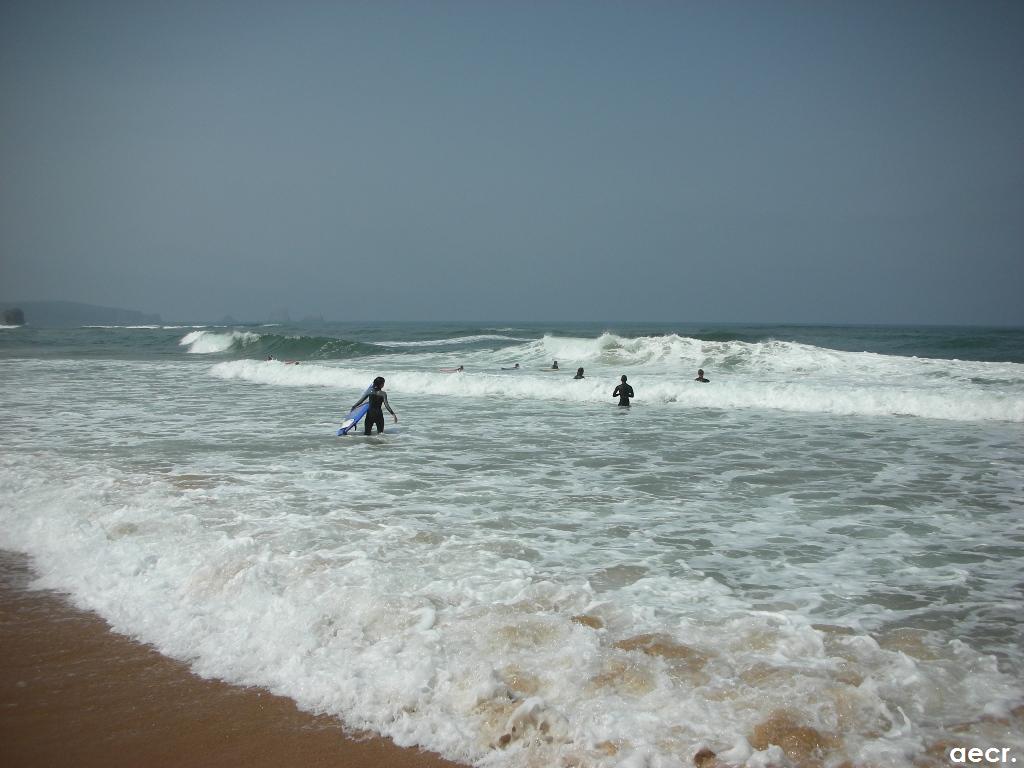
<box><xmin>0</xmin><ymin>436</ymin><xmax>1019</xmax><ymax>766</ymax></box>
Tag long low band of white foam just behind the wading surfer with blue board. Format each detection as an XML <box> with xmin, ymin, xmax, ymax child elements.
<box><xmin>211</xmin><ymin>350</ymin><xmax>1024</xmax><ymax>422</ymax></box>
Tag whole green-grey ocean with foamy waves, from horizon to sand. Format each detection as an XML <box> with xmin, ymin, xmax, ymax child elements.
<box><xmin>0</xmin><ymin>322</ymin><xmax>1024</xmax><ymax>768</ymax></box>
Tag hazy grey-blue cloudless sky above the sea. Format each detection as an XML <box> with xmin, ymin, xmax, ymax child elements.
<box><xmin>0</xmin><ymin>0</ymin><xmax>1024</xmax><ymax>325</ymax></box>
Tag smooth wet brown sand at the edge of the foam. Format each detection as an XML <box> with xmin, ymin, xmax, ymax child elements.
<box><xmin>0</xmin><ymin>552</ymin><xmax>459</xmax><ymax>768</ymax></box>
